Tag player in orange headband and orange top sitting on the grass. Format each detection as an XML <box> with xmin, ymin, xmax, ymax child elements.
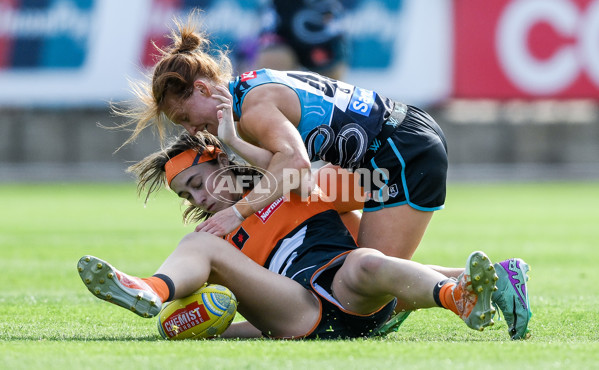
<box><xmin>80</xmin><ymin>134</ymin><xmax>532</xmax><ymax>339</ymax></box>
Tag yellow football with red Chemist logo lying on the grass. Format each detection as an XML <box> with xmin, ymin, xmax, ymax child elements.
<box><xmin>158</xmin><ymin>284</ymin><xmax>237</xmax><ymax>340</ymax></box>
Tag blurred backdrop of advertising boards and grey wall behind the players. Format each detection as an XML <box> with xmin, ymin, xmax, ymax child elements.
<box><xmin>0</xmin><ymin>0</ymin><xmax>599</xmax><ymax>182</ymax></box>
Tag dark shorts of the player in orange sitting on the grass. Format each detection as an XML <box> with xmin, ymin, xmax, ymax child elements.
<box><xmin>270</xmin><ymin>250</ymin><xmax>396</xmax><ymax>339</ymax></box>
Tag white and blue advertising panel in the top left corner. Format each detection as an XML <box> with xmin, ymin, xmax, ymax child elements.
<box><xmin>0</xmin><ymin>0</ymin><xmax>148</xmax><ymax>107</ymax></box>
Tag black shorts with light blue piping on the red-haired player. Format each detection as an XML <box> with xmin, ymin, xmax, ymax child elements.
<box><xmin>363</xmin><ymin>106</ymin><xmax>448</xmax><ymax>212</ymax></box>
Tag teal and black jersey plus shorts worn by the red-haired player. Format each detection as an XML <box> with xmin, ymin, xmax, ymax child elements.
<box><xmin>229</xmin><ymin>69</ymin><xmax>448</xmax><ymax>212</ymax></box>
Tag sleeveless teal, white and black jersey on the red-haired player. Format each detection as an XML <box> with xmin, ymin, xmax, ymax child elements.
<box><xmin>229</xmin><ymin>69</ymin><xmax>395</xmax><ymax>169</ymax></box>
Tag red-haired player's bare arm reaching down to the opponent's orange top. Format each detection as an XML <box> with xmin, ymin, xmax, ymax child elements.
<box><xmin>196</xmin><ymin>84</ymin><xmax>313</xmax><ymax>236</ymax></box>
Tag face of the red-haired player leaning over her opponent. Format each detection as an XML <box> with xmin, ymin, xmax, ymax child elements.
<box><xmin>165</xmin><ymin>85</ymin><xmax>219</xmax><ymax>136</ymax></box>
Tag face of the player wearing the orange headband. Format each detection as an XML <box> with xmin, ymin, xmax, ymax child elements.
<box><xmin>170</xmin><ymin>162</ymin><xmax>241</xmax><ymax>213</ymax></box>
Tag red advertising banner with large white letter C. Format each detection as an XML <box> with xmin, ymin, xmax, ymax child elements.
<box><xmin>454</xmin><ymin>0</ymin><xmax>599</xmax><ymax>99</ymax></box>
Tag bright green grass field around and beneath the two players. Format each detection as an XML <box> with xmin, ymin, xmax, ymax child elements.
<box><xmin>0</xmin><ymin>182</ymin><xmax>599</xmax><ymax>369</ymax></box>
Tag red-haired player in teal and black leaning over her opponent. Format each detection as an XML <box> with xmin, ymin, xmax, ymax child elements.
<box><xmin>122</xmin><ymin>13</ymin><xmax>530</xmax><ymax>338</ymax></box>
